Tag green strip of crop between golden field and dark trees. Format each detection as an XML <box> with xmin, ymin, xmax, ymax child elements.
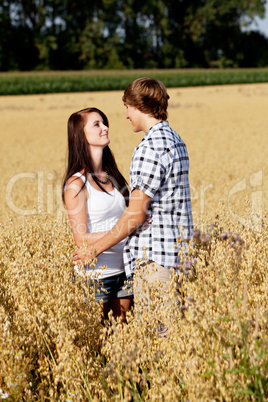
<box><xmin>0</xmin><ymin>69</ymin><xmax>268</xmax><ymax>95</ymax></box>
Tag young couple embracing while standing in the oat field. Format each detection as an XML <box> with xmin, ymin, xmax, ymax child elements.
<box><xmin>63</xmin><ymin>78</ymin><xmax>193</xmax><ymax>330</ymax></box>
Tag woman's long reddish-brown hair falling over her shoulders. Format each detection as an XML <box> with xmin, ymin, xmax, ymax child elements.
<box><xmin>62</xmin><ymin>107</ymin><xmax>129</xmax><ymax>205</ymax></box>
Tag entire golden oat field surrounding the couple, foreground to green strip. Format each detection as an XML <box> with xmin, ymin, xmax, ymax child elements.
<box><xmin>0</xmin><ymin>83</ymin><xmax>268</xmax><ymax>401</ymax></box>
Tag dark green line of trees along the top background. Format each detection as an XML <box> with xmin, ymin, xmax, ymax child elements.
<box><xmin>0</xmin><ymin>0</ymin><xmax>268</xmax><ymax>71</ymax></box>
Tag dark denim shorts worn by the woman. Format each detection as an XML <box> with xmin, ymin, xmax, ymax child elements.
<box><xmin>87</xmin><ymin>273</ymin><xmax>133</xmax><ymax>303</ymax></box>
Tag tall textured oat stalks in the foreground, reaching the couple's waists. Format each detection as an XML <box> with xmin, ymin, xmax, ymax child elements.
<box><xmin>0</xmin><ymin>210</ymin><xmax>268</xmax><ymax>401</ymax></box>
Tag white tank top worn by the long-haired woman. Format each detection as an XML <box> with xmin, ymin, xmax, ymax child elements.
<box><xmin>73</xmin><ymin>173</ymin><xmax>126</xmax><ymax>278</ymax></box>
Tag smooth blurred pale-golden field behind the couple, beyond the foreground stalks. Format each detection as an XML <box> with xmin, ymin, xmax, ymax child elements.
<box><xmin>0</xmin><ymin>84</ymin><xmax>268</xmax><ymax>222</ymax></box>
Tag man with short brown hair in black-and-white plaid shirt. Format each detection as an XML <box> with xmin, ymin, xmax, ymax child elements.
<box><xmin>73</xmin><ymin>78</ymin><xmax>193</xmax><ymax>332</ymax></box>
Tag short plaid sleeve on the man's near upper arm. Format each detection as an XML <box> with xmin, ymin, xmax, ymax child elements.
<box><xmin>130</xmin><ymin>147</ymin><xmax>165</xmax><ymax>198</ymax></box>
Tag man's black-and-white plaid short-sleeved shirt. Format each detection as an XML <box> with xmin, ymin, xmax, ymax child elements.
<box><xmin>124</xmin><ymin>121</ymin><xmax>193</xmax><ymax>277</ymax></box>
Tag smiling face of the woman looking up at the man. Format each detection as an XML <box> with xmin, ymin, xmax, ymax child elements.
<box><xmin>84</xmin><ymin>112</ymin><xmax>110</xmax><ymax>148</ymax></box>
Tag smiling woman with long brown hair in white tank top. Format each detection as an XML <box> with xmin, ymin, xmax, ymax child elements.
<box><xmin>63</xmin><ymin>107</ymin><xmax>133</xmax><ymax>321</ymax></box>
